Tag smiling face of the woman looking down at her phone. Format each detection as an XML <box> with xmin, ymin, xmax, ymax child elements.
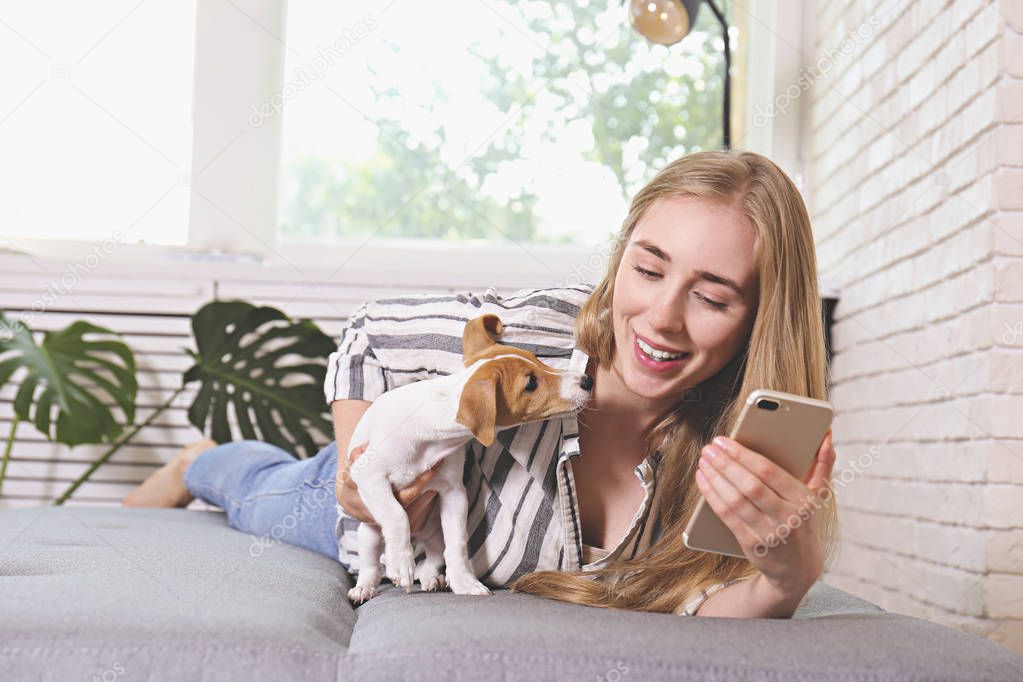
<box><xmin>612</xmin><ymin>192</ymin><xmax>757</xmax><ymax>404</ymax></box>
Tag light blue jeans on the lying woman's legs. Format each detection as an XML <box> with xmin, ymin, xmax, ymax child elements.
<box><xmin>184</xmin><ymin>441</ymin><xmax>338</xmax><ymax>560</ymax></box>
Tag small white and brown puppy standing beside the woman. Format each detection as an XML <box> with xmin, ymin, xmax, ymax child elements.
<box><xmin>348</xmin><ymin>314</ymin><xmax>593</xmax><ymax>603</ymax></box>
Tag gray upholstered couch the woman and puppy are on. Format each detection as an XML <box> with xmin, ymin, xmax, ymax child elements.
<box><xmin>0</xmin><ymin>507</ymin><xmax>1023</xmax><ymax>682</ymax></box>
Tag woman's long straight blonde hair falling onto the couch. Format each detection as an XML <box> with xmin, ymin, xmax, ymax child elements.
<box><xmin>510</xmin><ymin>151</ymin><xmax>837</xmax><ymax>612</ymax></box>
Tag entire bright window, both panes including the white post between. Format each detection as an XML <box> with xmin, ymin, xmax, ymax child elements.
<box><xmin>0</xmin><ymin>0</ymin><xmax>752</xmax><ymax>277</ymax></box>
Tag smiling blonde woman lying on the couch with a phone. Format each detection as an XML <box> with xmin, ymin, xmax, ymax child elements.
<box><xmin>125</xmin><ymin>151</ymin><xmax>836</xmax><ymax>618</ymax></box>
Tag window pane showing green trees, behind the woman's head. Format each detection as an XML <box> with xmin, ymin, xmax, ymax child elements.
<box><xmin>276</xmin><ymin>0</ymin><xmax>723</xmax><ymax>252</ymax></box>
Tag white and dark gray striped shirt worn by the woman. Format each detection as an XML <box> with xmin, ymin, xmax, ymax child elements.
<box><xmin>323</xmin><ymin>284</ymin><xmax>740</xmax><ymax>612</ymax></box>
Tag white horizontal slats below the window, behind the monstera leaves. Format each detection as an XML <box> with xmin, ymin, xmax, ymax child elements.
<box><xmin>0</xmin><ymin>258</ymin><xmax>546</xmax><ymax>507</ymax></box>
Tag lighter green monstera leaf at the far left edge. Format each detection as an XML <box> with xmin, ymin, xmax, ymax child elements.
<box><xmin>0</xmin><ymin>313</ymin><xmax>138</xmax><ymax>446</ymax></box>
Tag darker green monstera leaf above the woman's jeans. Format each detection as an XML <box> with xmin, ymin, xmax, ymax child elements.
<box><xmin>184</xmin><ymin>301</ymin><xmax>336</xmax><ymax>458</ymax></box>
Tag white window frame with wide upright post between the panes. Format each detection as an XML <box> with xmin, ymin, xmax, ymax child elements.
<box><xmin>7</xmin><ymin>0</ymin><xmax>785</xmax><ymax>284</ymax></box>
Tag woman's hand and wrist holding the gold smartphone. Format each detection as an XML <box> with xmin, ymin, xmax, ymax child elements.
<box><xmin>696</xmin><ymin>429</ymin><xmax>836</xmax><ymax>610</ymax></box>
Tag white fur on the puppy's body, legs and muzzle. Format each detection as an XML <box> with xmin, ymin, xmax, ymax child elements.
<box><xmin>348</xmin><ymin>354</ymin><xmax>589</xmax><ymax>603</ymax></box>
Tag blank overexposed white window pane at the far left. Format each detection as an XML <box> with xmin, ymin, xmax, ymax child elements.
<box><xmin>0</xmin><ymin>0</ymin><xmax>195</xmax><ymax>245</ymax></box>
